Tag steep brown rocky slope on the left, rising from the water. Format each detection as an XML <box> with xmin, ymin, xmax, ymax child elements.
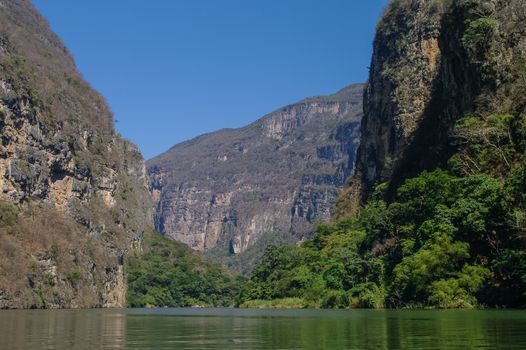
<box><xmin>0</xmin><ymin>0</ymin><xmax>153</xmax><ymax>308</ymax></box>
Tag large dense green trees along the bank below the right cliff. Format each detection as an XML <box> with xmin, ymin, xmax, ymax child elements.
<box><xmin>241</xmin><ymin>165</ymin><xmax>526</xmax><ymax>308</ymax></box>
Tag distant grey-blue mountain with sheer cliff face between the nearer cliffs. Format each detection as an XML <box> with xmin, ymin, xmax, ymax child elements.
<box><xmin>147</xmin><ymin>85</ymin><xmax>363</xmax><ymax>253</ymax></box>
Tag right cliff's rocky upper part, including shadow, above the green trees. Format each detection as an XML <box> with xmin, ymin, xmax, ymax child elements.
<box><xmin>337</xmin><ymin>0</ymin><xmax>526</xmax><ymax>217</ymax></box>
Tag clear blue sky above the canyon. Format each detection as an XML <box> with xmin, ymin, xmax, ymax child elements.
<box><xmin>34</xmin><ymin>0</ymin><xmax>388</xmax><ymax>158</ymax></box>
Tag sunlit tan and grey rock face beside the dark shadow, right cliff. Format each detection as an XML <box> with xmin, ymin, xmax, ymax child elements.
<box><xmin>339</xmin><ymin>0</ymin><xmax>450</xmax><ymax>214</ymax></box>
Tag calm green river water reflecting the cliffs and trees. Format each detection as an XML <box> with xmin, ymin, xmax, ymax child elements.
<box><xmin>0</xmin><ymin>309</ymin><xmax>526</xmax><ymax>350</ymax></box>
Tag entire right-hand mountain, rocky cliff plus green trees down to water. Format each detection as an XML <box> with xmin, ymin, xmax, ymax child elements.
<box><xmin>239</xmin><ymin>0</ymin><xmax>526</xmax><ymax>308</ymax></box>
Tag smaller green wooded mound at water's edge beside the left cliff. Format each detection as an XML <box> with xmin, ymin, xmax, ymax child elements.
<box><xmin>126</xmin><ymin>232</ymin><xmax>244</xmax><ymax>307</ymax></box>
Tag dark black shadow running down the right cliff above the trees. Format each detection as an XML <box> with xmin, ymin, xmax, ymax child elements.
<box><xmin>386</xmin><ymin>4</ymin><xmax>488</xmax><ymax>200</ymax></box>
